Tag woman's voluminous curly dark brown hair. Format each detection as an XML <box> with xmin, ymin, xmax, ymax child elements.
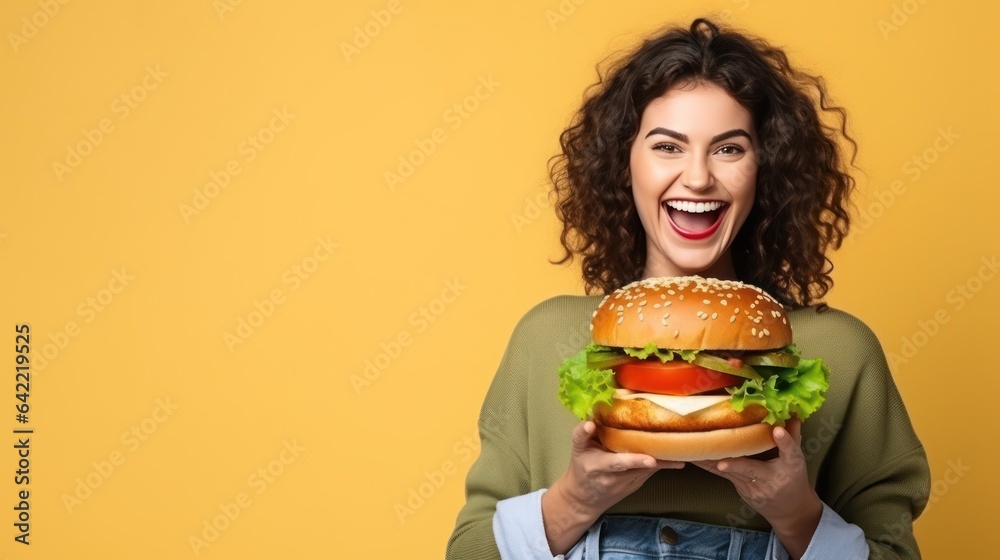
<box><xmin>549</xmin><ymin>18</ymin><xmax>857</xmax><ymax>310</ymax></box>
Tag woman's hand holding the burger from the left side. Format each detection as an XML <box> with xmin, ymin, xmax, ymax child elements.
<box><xmin>542</xmin><ymin>421</ymin><xmax>684</xmax><ymax>555</ymax></box>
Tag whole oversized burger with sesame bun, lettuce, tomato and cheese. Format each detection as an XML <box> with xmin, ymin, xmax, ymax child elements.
<box><xmin>559</xmin><ymin>276</ymin><xmax>829</xmax><ymax>461</ymax></box>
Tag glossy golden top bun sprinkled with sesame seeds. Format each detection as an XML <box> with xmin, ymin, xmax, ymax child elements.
<box><xmin>591</xmin><ymin>276</ymin><xmax>792</xmax><ymax>350</ymax></box>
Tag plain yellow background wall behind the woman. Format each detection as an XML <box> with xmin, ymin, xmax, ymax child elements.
<box><xmin>0</xmin><ymin>0</ymin><xmax>1000</xmax><ymax>559</ymax></box>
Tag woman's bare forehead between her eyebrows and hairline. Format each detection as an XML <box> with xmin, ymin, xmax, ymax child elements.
<box><xmin>640</xmin><ymin>84</ymin><xmax>753</xmax><ymax>133</ymax></box>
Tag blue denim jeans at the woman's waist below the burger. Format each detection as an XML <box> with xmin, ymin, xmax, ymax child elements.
<box><xmin>583</xmin><ymin>515</ymin><xmax>771</xmax><ymax>560</ymax></box>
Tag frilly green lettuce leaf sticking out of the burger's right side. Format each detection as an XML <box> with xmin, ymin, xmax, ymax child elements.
<box><xmin>729</xmin><ymin>356</ymin><xmax>830</xmax><ymax>424</ymax></box>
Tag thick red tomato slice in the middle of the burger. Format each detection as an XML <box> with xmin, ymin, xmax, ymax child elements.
<box><xmin>612</xmin><ymin>360</ymin><xmax>746</xmax><ymax>395</ymax></box>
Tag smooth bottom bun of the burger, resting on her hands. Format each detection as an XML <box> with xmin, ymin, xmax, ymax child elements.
<box><xmin>597</xmin><ymin>423</ymin><xmax>776</xmax><ymax>461</ymax></box>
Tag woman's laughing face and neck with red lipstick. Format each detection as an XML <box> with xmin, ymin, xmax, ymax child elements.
<box><xmin>629</xmin><ymin>80</ymin><xmax>757</xmax><ymax>279</ymax></box>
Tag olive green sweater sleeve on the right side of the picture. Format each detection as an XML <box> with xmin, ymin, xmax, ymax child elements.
<box><xmin>819</xmin><ymin>321</ymin><xmax>930</xmax><ymax>559</ymax></box>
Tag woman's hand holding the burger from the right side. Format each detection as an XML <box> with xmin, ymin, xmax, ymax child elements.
<box><xmin>695</xmin><ymin>418</ymin><xmax>823</xmax><ymax>559</ymax></box>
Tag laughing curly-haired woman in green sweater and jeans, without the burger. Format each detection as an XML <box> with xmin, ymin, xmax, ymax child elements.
<box><xmin>448</xmin><ymin>19</ymin><xmax>929</xmax><ymax>560</ymax></box>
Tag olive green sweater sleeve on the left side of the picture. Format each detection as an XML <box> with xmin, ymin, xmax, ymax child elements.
<box><xmin>445</xmin><ymin>312</ymin><xmax>532</xmax><ymax>560</ymax></box>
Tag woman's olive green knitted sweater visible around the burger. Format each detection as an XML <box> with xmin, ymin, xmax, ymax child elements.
<box><xmin>447</xmin><ymin>296</ymin><xmax>930</xmax><ymax>560</ymax></box>
